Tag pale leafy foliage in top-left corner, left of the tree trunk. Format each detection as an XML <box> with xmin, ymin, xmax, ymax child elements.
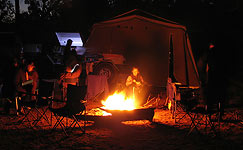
<box><xmin>0</xmin><ymin>0</ymin><xmax>15</xmax><ymax>23</ymax></box>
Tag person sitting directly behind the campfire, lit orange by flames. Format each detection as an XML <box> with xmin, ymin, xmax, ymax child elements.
<box><xmin>126</xmin><ymin>67</ymin><xmax>144</xmax><ymax>103</ymax></box>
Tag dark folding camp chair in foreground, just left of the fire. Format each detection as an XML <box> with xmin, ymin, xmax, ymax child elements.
<box><xmin>49</xmin><ymin>84</ymin><xmax>87</xmax><ymax>136</ymax></box>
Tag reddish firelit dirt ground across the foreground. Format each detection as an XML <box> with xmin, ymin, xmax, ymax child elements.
<box><xmin>0</xmin><ymin>101</ymin><xmax>243</xmax><ymax>150</ymax></box>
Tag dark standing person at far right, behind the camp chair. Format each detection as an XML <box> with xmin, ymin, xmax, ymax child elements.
<box><xmin>206</xmin><ymin>43</ymin><xmax>227</xmax><ymax>117</ymax></box>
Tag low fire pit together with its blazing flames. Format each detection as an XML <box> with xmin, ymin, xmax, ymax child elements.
<box><xmin>84</xmin><ymin>89</ymin><xmax>155</xmax><ymax>121</ymax></box>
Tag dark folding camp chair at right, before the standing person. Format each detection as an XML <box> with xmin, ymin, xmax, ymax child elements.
<box><xmin>187</xmin><ymin>103</ymin><xmax>220</xmax><ymax>135</ymax></box>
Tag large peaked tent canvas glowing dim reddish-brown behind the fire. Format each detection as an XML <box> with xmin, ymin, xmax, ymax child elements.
<box><xmin>84</xmin><ymin>9</ymin><xmax>199</xmax><ymax>87</ymax></box>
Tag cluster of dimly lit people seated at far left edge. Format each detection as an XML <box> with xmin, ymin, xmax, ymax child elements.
<box><xmin>2</xmin><ymin>58</ymin><xmax>39</xmax><ymax>113</ymax></box>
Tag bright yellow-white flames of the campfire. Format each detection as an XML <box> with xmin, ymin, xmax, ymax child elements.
<box><xmin>101</xmin><ymin>91</ymin><xmax>139</xmax><ymax>110</ymax></box>
